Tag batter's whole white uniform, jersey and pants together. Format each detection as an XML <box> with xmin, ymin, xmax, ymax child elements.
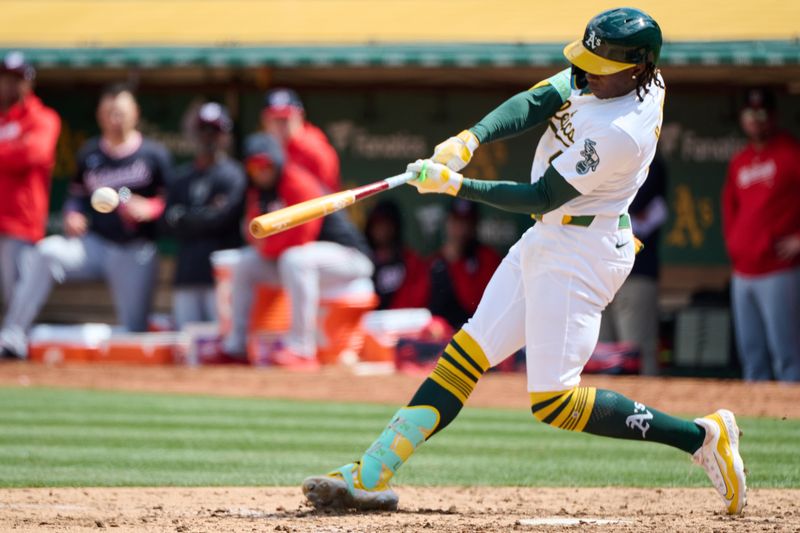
<box><xmin>464</xmin><ymin>71</ymin><xmax>664</xmax><ymax>392</ymax></box>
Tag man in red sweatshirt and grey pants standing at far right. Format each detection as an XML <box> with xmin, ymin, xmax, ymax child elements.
<box><xmin>722</xmin><ymin>89</ymin><xmax>800</xmax><ymax>381</ymax></box>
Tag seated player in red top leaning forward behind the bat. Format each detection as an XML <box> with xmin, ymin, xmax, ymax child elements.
<box><xmin>223</xmin><ymin>133</ymin><xmax>373</xmax><ymax>369</ymax></box>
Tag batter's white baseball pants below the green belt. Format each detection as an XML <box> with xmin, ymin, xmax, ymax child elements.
<box><xmin>464</xmin><ymin>217</ymin><xmax>634</xmax><ymax>392</ymax></box>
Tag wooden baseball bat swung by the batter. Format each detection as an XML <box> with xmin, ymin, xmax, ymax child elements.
<box><xmin>250</xmin><ymin>172</ymin><xmax>416</xmax><ymax>239</ymax></box>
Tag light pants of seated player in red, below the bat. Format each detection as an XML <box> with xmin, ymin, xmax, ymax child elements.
<box><xmin>224</xmin><ymin>241</ymin><xmax>374</xmax><ymax>357</ymax></box>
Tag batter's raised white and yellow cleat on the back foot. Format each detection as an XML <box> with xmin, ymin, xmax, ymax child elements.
<box><xmin>692</xmin><ymin>409</ymin><xmax>747</xmax><ymax>514</ymax></box>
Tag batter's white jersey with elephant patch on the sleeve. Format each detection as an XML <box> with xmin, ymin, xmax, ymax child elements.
<box><xmin>531</xmin><ymin>69</ymin><xmax>664</xmax><ymax>223</ymax></box>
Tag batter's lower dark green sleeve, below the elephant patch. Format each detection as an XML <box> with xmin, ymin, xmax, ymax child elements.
<box><xmin>458</xmin><ymin>166</ymin><xmax>581</xmax><ymax>215</ymax></box>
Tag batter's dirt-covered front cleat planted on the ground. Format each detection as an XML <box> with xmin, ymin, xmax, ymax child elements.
<box><xmin>303</xmin><ymin>462</ymin><xmax>399</xmax><ymax>511</ymax></box>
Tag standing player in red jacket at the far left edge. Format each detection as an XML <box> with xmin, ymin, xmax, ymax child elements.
<box><xmin>0</xmin><ymin>52</ymin><xmax>61</xmax><ymax>307</ymax></box>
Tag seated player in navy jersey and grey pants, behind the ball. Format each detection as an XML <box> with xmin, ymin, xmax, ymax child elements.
<box><xmin>0</xmin><ymin>85</ymin><xmax>171</xmax><ymax>357</ymax></box>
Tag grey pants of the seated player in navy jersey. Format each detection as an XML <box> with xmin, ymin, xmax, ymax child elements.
<box><xmin>0</xmin><ymin>232</ymin><xmax>158</xmax><ymax>354</ymax></box>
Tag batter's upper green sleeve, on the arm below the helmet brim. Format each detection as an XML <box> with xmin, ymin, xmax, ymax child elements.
<box><xmin>470</xmin><ymin>69</ymin><xmax>572</xmax><ymax>144</ymax></box>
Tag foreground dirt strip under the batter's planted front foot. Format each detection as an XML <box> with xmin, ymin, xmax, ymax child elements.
<box><xmin>0</xmin><ymin>487</ymin><xmax>800</xmax><ymax>533</ymax></box>
